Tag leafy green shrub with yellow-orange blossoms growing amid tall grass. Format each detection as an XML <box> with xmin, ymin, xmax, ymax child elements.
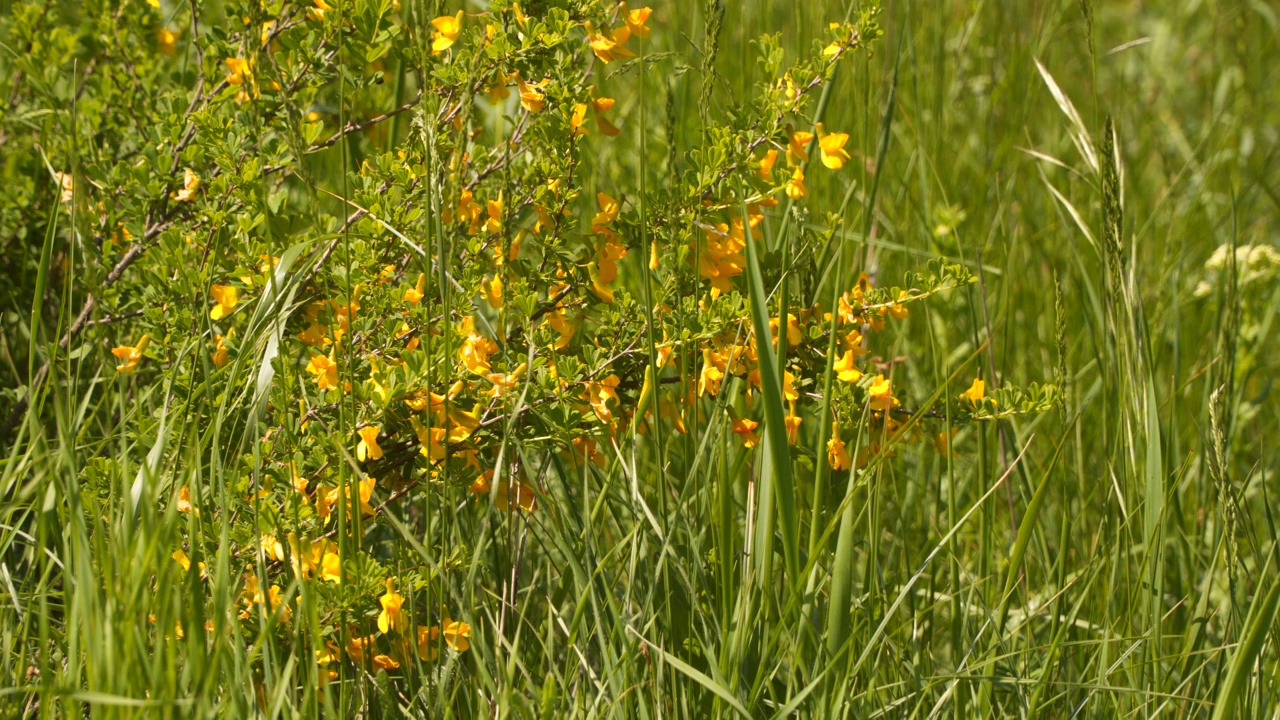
<box><xmin>0</xmin><ymin>0</ymin><xmax>1056</xmax><ymax>707</ymax></box>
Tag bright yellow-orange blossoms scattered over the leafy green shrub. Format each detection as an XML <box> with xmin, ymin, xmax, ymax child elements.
<box><xmin>104</xmin><ymin>0</ymin><xmax>942</xmax><ymax>675</ymax></box>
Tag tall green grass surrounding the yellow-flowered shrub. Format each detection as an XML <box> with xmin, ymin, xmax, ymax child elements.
<box><xmin>0</xmin><ymin>0</ymin><xmax>1280</xmax><ymax>720</ymax></box>
